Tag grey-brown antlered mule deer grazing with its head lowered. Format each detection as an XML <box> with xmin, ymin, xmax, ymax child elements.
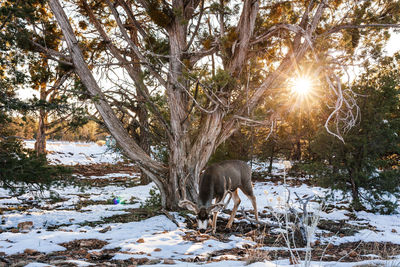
<box><xmin>179</xmin><ymin>160</ymin><xmax>258</xmax><ymax>233</ymax></box>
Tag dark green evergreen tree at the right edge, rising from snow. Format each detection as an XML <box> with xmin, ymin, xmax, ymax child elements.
<box><xmin>306</xmin><ymin>58</ymin><xmax>400</xmax><ymax>213</ymax></box>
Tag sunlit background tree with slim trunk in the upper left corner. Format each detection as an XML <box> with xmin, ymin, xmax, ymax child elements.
<box><xmin>0</xmin><ymin>0</ymin><xmax>95</xmax><ymax>154</ymax></box>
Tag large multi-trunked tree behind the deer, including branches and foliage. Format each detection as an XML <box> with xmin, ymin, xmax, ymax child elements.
<box><xmin>5</xmin><ymin>0</ymin><xmax>399</xmax><ymax>209</ymax></box>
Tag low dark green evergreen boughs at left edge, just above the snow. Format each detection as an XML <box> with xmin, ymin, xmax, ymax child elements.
<box><xmin>0</xmin><ymin>91</ymin><xmax>70</xmax><ymax>194</ymax></box>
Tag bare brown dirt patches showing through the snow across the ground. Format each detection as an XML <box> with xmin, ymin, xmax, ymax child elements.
<box><xmin>0</xmin><ymin>166</ymin><xmax>400</xmax><ymax>267</ymax></box>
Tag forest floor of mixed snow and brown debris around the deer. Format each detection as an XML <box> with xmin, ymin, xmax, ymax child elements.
<box><xmin>0</xmin><ymin>142</ymin><xmax>400</xmax><ymax>266</ymax></box>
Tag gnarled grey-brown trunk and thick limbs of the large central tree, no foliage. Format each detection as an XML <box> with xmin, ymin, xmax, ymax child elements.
<box><xmin>49</xmin><ymin>0</ymin><xmax>320</xmax><ymax>210</ymax></box>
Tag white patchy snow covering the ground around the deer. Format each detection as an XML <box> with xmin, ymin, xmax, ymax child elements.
<box><xmin>0</xmin><ymin>142</ymin><xmax>400</xmax><ymax>267</ymax></box>
